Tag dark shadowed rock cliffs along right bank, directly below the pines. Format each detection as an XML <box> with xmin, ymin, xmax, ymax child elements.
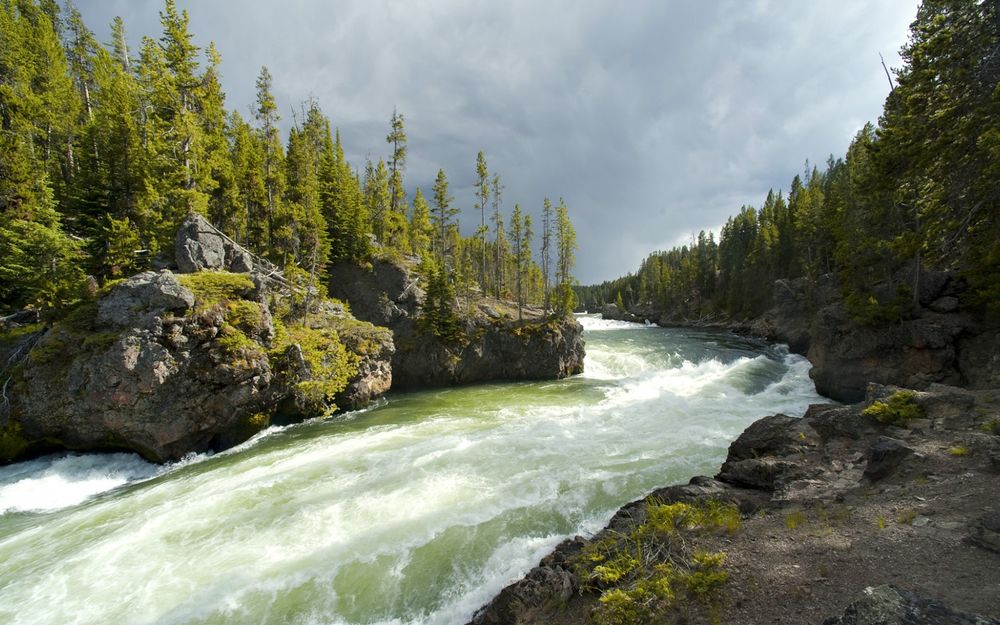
<box><xmin>601</xmin><ymin>272</ymin><xmax>1000</xmax><ymax>402</ymax></box>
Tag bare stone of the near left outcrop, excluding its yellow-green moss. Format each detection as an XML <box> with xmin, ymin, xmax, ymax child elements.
<box><xmin>0</xmin><ymin>270</ymin><xmax>393</xmax><ymax>462</ymax></box>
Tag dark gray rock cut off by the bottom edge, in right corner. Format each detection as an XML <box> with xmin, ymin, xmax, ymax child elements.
<box><xmin>823</xmin><ymin>586</ymin><xmax>1000</xmax><ymax>625</ymax></box>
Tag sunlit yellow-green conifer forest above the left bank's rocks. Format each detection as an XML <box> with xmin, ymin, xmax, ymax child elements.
<box><xmin>0</xmin><ymin>0</ymin><xmax>576</xmax><ymax>314</ymax></box>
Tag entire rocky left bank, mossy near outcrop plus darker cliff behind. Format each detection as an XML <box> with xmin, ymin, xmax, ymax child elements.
<box><xmin>0</xmin><ymin>215</ymin><xmax>584</xmax><ymax>463</ymax></box>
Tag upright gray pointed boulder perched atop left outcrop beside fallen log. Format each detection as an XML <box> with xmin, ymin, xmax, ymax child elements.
<box><xmin>174</xmin><ymin>213</ymin><xmax>255</xmax><ymax>273</ymax></box>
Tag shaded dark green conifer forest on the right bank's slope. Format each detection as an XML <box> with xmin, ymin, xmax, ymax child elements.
<box><xmin>578</xmin><ymin>0</ymin><xmax>1000</xmax><ymax>323</ymax></box>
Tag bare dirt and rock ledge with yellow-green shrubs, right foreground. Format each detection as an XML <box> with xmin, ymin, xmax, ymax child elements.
<box><xmin>472</xmin><ymin>385</ymin><xmax>1000</xmax><ymax>625</ymax></box>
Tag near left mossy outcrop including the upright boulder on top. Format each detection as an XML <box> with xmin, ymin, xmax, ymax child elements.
<box><xmin>0</xmin><ymin>217</ymin><xmax>395</xmax><ymax>462</ymax></box>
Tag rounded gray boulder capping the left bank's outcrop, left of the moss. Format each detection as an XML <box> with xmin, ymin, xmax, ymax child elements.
<box><xmin>97</xmin><ymin>269</ymin><xmax>194</xmax><ymax>327</ymax></box>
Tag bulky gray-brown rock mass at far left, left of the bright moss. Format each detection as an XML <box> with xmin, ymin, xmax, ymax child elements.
<box><xmin>14</xmin><ymin>271</ymin><xmax>272</xmax><ymax>462</ymax></box>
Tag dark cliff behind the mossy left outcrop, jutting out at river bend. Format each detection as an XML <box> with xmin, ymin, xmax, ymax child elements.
<box><xmin>329</xmin><ymin>260</ymin><xmax>584</xmax><ymax>388</ymax></box>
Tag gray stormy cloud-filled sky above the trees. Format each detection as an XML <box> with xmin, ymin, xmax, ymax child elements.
<box><xmin>77</xmin><ymin>0</ymin><xmax>917</xmax><ymax>284</ymax></box>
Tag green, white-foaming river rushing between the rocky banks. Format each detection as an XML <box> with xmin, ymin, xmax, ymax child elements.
<box><xmin>0</xmin><ymin>317</ymin><xmax>823</xmax><ymax>625</ymax></box>
